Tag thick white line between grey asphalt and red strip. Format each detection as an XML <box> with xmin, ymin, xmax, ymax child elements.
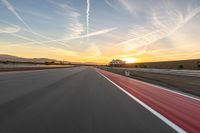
<box><xmin>97</xmin><ymin>71</ymin><xmax>187</xmax><ymax>133</ymax></box>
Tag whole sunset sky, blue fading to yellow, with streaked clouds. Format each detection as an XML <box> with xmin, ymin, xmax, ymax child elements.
<box><xmin>0</xmin><ymin>0</ymin><xmax>200</xmax><ymax>64</ymax></box>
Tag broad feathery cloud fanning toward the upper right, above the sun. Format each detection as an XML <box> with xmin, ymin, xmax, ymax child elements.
<box><xmin>116</xmin><ymin>0</ymin><xmax>200</xmax><ymax>54</ymax></box>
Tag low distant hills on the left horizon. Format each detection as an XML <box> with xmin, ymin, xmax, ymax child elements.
<box><xmin>0</xmin><ymin>54</ymin><xmax>69</xmax><ymax>63</ymax></box>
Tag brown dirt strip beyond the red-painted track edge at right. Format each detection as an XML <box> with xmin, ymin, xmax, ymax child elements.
<box><xmin>102</xmin><ymin>68</ymin><xmax>200</xmax><ymax>96</ymax></box>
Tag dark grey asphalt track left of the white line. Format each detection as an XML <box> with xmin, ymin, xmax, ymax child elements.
<box><xmin>0</xmin><ymin>67</ymin><xmax>176</xmax><ymax>133</ymax></box>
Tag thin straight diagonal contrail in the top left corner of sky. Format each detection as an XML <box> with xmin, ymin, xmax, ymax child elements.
<box><xmin>1</xmin><ymin>0</ymin><xmax>32</xmax><ymax>31</ymax></box>
